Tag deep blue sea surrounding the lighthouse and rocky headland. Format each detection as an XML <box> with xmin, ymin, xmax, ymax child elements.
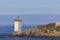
<box><xmin>0</xmin><ymin>25</ymin><xmax>60</xmax><ymax>40</ymax></box>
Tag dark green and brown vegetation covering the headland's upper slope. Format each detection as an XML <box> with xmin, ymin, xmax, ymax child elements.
<box><xmin>37</xmin><ymin>23</ymin><xmax>60</xmax><ymax>32</ymax></box>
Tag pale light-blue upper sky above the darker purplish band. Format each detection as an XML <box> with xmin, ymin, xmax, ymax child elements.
<box><xmin>0</xmin><ymin>0</ymin><xmax>60</xmax><ymax>15</ymax></box>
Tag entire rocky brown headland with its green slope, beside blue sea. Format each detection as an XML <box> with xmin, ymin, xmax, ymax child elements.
<box><xmin>10</xmin><ymin>25</ymin><xmax>60</xmax><ymax>37</ymax></box>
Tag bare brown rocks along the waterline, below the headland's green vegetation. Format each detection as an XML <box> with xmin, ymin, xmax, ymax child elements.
<box><xmin>10</xmin><ymin>30</ymin><xmax>60</xmax><ymax>37</ymax></box>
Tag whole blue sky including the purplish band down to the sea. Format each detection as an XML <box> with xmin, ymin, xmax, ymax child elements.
<box><xmin>0</xmin><ymin>0</ymin><xmax>60</xmax><ymax>25</ymax></box>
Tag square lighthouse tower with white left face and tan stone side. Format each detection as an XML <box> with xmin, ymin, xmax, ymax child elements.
<box><xmin>14</xmin><ymin>17</ymin><xmax>22</xmax><ymax>34</ymax></box>
